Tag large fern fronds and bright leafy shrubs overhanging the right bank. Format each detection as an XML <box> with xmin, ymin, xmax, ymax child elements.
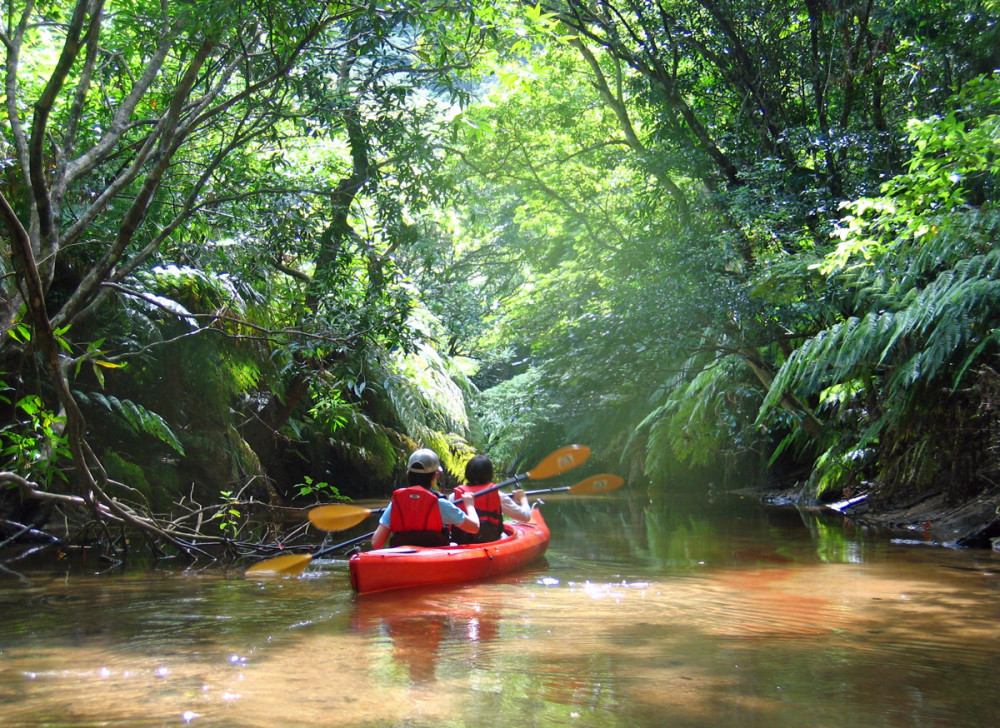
<box><xmin>761</xmin><ymin>78</ymin><xmax>1000</xmax><ymax>504</ymax></box>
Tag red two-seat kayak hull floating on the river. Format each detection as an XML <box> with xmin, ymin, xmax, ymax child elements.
<box><xmin>349</xmin><ymin>508</ymin><xmax>549</xmax><ymax>594</ymax></box>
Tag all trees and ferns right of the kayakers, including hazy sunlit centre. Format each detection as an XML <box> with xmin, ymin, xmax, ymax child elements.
<box><xmin>442</xmin><ymin>0</ymin><xmax>1000</xmax><ymax>506</ymax></box>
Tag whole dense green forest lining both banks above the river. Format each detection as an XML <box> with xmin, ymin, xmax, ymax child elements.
<box><xmin>0</xmin><ymin>0</ymin><xmax>1000</xmax><ymax>555</ymax></box>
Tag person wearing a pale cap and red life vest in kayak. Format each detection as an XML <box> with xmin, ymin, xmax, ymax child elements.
<box><xmin>372</xmin><ymin>448</ymin><xmax>479</xmax><ymax>549</ymax></box>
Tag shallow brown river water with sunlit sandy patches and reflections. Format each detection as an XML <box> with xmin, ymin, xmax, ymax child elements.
<box><xmin>0</xmin><ymin>491</ymin><xmax>1000</xmax><ymax>728</ymax></box>
